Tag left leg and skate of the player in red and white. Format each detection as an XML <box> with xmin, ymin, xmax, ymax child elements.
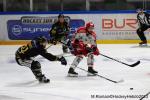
<box><xmin>68</xmin><ymin>56</ymin><xmax>83</xmax><ymax>76</ymax></box>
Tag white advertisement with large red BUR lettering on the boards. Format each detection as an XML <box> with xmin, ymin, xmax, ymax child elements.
<box><xmin>101</xmin><ymin>14</ymin><xmax>138</xmax><ymax>39</ymax></box>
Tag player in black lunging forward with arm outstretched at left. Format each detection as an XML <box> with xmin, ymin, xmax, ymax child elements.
<box><xmin>15</xmin><ymin>37</ymin><xmax>67</xmax><ymax>83</ymax></box>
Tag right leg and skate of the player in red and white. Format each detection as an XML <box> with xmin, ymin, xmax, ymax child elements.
<box><xmin>87</xmin><ymin>53</ymin><xmax>98</xmax><ymax>75</ymax></box>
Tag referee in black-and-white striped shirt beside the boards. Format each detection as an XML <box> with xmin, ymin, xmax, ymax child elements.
<box><xmin>137</xmin><ymin>9</ymin><xmax>150</xmax><ymax>46</ymax></box>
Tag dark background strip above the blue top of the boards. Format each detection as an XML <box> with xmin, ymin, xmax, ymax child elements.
<box><xmin>0</xmin><ymin>0</ymin><xmax>150</xmax><ymax>12</ymax></box>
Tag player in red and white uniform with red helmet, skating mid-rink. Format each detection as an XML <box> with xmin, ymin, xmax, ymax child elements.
<box><xmin>68</xmin><ymin>22</ymin><xmax>99</xmax><ymax>76</ymax></box>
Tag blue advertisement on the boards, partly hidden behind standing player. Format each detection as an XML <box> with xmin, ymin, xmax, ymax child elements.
<box><xmin>7</xmin><ymin>16</ymin><xmax>85</xmax><ymax>40</ymax></box>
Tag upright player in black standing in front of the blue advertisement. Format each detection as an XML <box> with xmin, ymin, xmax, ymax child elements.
<box><xmin>49</xmin><ymin>14</ymin><xmax>70</xmax><ymax>53</ymax></box>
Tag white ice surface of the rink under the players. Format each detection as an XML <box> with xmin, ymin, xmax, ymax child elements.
<box><xmin>0</xmin><ymin>44</ymin><xmax>150</xmax><ymax>100</ymax></box>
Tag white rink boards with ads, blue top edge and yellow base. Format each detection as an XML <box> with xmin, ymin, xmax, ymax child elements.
<box><xmin>0</xmin><ymin>11</ymin><xmax>150</xmax><ymax>44</ymax></box>
